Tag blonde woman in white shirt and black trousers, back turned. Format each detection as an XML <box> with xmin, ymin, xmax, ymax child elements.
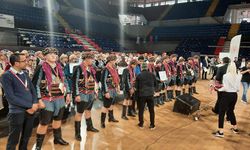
<box><xmin>214</xmin><ymin>63</ymin><xmax>241</xmax><ymax>138</ymax></box>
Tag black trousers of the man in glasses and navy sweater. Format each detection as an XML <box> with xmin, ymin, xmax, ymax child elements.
<box><xmin>6</xmin><ymin>112</ymin><xmax>35</xmax><ymax>150</ymax></box>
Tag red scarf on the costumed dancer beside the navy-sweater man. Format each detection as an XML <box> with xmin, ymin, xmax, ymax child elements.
<box><xmin>42</xmin><ymin>62</ymin><xmax>64</xmax><ymax>90</ymax></box>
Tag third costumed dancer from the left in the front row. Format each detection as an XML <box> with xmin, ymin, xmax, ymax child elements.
<box><xmin>101</xmin><ymin>54</ymin><xmax>120</xmax><ymax>128</ymax></box>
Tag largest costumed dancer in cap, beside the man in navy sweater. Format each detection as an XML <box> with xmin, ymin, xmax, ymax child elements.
<box><xmin>33</xmin><ymin>47</ymin><xmax>70</xmax><ymax>150</ymax></box>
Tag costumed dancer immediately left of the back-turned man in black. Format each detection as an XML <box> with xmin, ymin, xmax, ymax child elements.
<box><xmin>122</xmin><ymin>59</ymin><xmax>137</xmax><ymax>120</ymax></box>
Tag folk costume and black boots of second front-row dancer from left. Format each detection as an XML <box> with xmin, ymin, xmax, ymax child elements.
<box><xmin>73</xmin><ymin>59</ymin><xmax>99</xmax><ymax>141</ymax></box>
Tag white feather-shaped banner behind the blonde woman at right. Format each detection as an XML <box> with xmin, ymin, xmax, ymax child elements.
<box><xmin>229</xmin><ymin>35</ymin><xmax>242</xmax><ymax>61</ymax></box>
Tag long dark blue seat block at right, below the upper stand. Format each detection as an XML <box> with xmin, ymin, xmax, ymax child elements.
<box><xmin>151</xmin><ymin>24</ymin><xmax>230</xmax><ymax>41</ymax></box>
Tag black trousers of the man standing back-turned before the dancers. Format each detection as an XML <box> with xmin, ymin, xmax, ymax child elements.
<box><xmin>137</xmin><ymin>96</ymin><xmax>155</xmax><ymax>125</ymax></box>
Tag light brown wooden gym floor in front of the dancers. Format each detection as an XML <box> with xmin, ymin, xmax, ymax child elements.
<box><xmin>0</xmin><ymin>80</ymin><xmax>250</xmax><ymax>150</ymax></box>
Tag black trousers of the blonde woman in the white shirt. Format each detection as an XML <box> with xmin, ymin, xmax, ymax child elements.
<box><xmin>218</xmin><ymin>92</ymin><xmax>237</xmax><ymax>128</ymax></box>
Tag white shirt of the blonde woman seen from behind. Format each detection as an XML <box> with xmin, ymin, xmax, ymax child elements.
<box><xmin>219</xmin><ymin>73</ymin><xmax>242</xmax><ymax>92</ymax></box>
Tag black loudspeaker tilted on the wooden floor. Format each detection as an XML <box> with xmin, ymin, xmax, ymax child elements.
<box><xmin>173</xmin><ymin>94</ymin><xmax>200</xmax><ymax>115</ymax></box>
